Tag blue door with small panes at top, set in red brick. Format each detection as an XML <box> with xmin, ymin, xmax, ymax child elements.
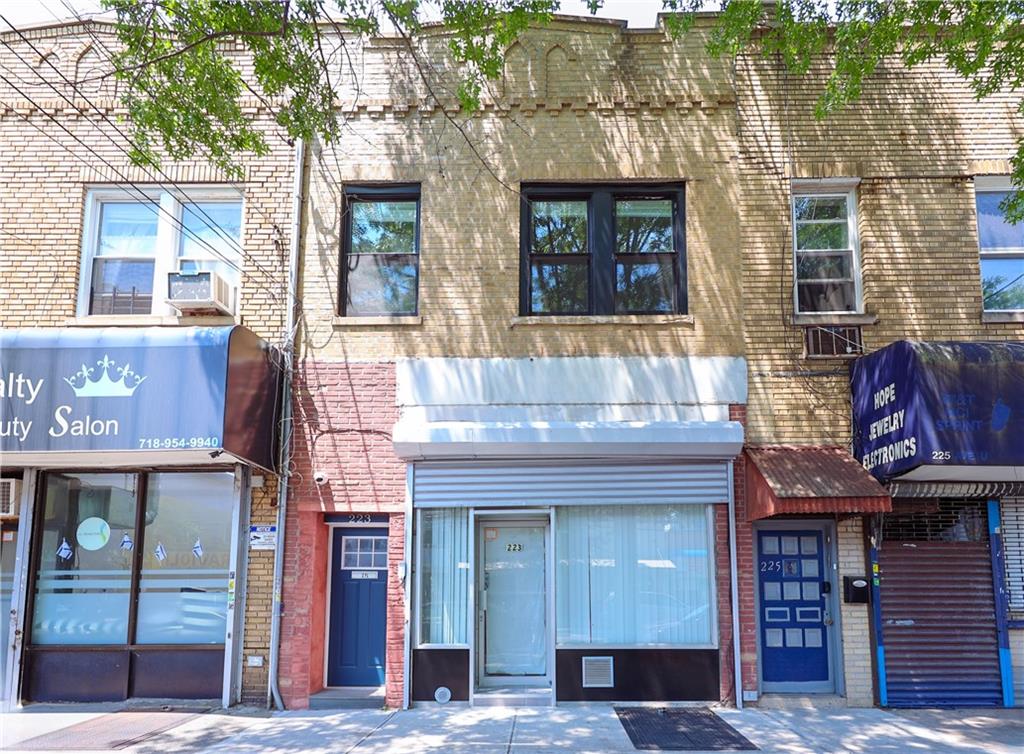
<box><xmin>327</xmin><ymin>529</ymin><xmax>387</xmax><ymax>686</ymax></box>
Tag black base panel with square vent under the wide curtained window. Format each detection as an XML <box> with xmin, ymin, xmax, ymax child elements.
<box><xmin>555</xmin><ymin>647</ymin><xmax>719</xmax><ymax>702</ymax></box>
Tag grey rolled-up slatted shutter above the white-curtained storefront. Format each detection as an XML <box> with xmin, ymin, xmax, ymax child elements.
<box><xmin>413</xmin><ymin>463</ymin><xmax>729</xmax><ymax>508</ymax></box>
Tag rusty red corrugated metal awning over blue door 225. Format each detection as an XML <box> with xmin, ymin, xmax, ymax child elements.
<box><xmin>744</xmin><ymin>446</ymin><xmax>892</xmax><ymax>520</ymax></box>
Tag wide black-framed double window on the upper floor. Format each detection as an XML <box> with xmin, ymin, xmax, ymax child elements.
<box><xmin>519</xmin><ymin>183</ymin><xmax>687</xmax><ymax>316</ymax></box>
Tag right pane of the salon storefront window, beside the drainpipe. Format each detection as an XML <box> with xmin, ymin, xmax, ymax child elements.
<box><xmin>135</xmin><ymin>473</ymin><xmax>234</xmax><ymax>644</ymax></box>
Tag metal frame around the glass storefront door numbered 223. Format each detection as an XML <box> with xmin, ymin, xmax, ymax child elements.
<box><xmin>470</xmin><ymin>508</ymin><xmax>555</xmax><ymax>692</ymax></box>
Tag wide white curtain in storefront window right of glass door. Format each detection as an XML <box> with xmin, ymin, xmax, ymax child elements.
<box><xmin>555</xmin><ymin>505</ymin><xmax>714</xmax><ymax>645</ymax></box>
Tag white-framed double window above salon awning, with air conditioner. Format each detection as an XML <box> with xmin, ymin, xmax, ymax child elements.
<box><xmin>78</xmin><ymin>187</ymin><xmax>243</xmax><ymax>317</ymax></box>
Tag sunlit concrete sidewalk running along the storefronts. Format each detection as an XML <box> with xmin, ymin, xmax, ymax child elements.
<box><xmin>0</xmin><ymin>705</ymin><xmax>1024</xmax><ymax>754</ymax></box>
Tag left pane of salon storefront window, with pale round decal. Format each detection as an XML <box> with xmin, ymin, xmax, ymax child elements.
<box><xmin>32</xmin><ymin>474</ymin><xmax>138</xmax><ymax>644</ymax></box>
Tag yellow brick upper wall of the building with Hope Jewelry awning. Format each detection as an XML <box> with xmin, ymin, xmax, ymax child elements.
<box><xmin>736</xmin><ymin>55</ymin><xmax>1024</xmax><ymax>445</ymax></box>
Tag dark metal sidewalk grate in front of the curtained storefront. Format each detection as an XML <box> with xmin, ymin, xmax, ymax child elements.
<box><xmin>615</xmin><ymin>707</ymin><xmax>758</xmax><ymax>751</ymax></box>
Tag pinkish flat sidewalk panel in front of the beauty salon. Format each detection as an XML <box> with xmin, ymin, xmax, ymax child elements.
<box><xmin>17</xmin><ymin>712</ymin><xmax>199</xmax><ymax>751</ymax></box>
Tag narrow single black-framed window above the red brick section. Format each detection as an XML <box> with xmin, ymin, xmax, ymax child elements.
<box><xmin>339</xmin><ymin>184</ymin><xmax>420</xmax><ymax>317</ymax></box>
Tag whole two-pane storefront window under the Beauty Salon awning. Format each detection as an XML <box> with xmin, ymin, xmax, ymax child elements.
<box><xmin>31</xmin><ymin>472</ymin><xmax>236</xmax><ymax>645</ymax></box>
